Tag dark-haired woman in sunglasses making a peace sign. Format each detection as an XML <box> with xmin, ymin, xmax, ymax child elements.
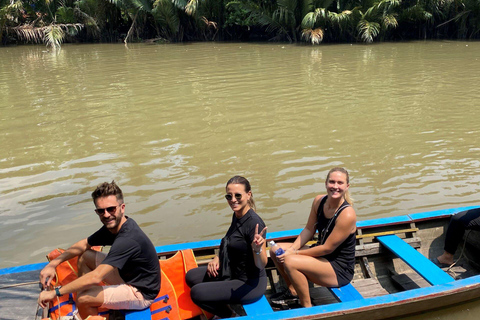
<box><xmin>186</xmin><ymin>176</ymin><xmax>267</xmax><ymax>319</ymax></box>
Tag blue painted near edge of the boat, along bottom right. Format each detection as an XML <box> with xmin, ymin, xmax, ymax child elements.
<box><xmin>234</xmin><ymin>275</ymin><xmax>480</xmax><ymax>320</ymax></box>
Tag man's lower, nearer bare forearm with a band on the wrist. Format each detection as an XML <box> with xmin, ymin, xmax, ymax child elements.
<box><xmin>38</xmin><ymin>264</ymin><xmax>114</xmax><ymax>308</ymax></box>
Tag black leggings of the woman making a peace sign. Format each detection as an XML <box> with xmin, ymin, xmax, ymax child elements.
<box><xmin>186</xmin><ymin>266</ymin><xmax>267</xmax><ymax>318</ymax></box>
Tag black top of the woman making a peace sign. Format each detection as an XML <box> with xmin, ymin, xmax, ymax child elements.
<box><xmin>226</xmin><ymin>209</ymin><xmax>267</xmax><ymax>281</ymax></box>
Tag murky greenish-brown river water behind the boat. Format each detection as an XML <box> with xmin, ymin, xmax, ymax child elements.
<box><xmin>0</xmin><ymin>41</ymin><xmax>480</xmax><ymax>319</ymax></box>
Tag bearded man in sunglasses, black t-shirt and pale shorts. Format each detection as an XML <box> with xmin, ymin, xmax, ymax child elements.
<box><xmin>38</xmin><ymin>181</ymin><xmax>160</xmax><ymax>319</ymax></box>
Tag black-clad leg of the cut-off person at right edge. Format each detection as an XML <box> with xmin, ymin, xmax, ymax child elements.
<box><xmin>444</xmin><ymin>208</ymin><xmax>480</xmax><ymax>254</ymax></box>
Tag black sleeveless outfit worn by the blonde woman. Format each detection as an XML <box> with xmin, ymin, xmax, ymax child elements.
<box><xmin>316</xmin><ymin>196</ymin><xmax>355</xmax><ymax>264</ymax></box>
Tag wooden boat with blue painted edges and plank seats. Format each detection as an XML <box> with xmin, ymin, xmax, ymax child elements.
<box><xmin>0</xmin><ymin>207</ymin><xmax>480</xmax><ymax>320</ymax></box>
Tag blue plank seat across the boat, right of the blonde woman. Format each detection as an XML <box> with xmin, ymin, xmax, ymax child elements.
<box><xmin>377</xmin><ymin>234</ymin><xmax>454</xmax><ymax>285</ymax></box>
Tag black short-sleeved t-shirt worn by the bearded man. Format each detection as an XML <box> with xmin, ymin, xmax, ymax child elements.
<box><xmin>87</xmin><ymin>217</ymin><xmax>160</xmax><ymax>300</ymax></box>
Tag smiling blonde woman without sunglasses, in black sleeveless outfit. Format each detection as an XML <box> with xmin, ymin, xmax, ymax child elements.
<box><xmin>270</xmin><ymin>168</ymin><xmax>356</xmax><ymax>307</ymax></box>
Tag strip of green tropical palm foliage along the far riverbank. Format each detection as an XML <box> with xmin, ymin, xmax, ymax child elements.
<box><xmin>0</xmin><ymin>0</ymin><xmax>480</xmax><ymax>49</ymax></box>
